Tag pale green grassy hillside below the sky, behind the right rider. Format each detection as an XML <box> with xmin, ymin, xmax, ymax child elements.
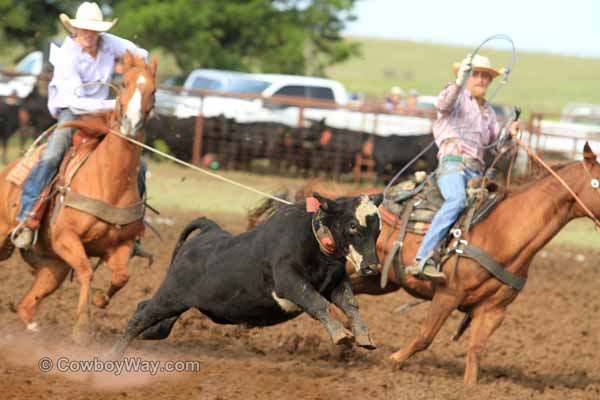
<box><xmin>327</xmin><ymin>38</ymin><xmax>600</xmax><ymax>112</ymax></box>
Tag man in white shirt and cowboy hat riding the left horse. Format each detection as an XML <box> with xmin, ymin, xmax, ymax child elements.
<box><xmin>11</xmin><ymin>2</ymin><xmax>148</xmax><ymax>248</ymax></box>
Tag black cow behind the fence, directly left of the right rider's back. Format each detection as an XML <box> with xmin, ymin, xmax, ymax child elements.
<box><xmin>372</xmin><ymin>133</ymin><xmax>438</xmax><ymax>180</ymax></box>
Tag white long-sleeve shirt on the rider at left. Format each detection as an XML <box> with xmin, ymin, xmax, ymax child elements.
<box><xmin>48</xmin><ymin>32</ymin><xmax>148</xmax><ymax>118</ymax></box>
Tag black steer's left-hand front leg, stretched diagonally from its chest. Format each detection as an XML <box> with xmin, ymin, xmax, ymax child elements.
<box><xmin>274</xmin><ymin>267</ymin><xmax>352</xmax><ymax>344</ymax></box>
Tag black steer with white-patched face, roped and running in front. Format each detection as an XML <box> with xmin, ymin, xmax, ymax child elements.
<box><xmin>113</xmin><ymin>194</ymin><xmax>382</xmax><ymax>355</ymax></box>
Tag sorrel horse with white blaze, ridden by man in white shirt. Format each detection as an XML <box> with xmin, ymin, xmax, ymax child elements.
<box><xmin>0</xmin><ymin>52</ymin><xmax>157</xmax><ymax>343</ymax></box>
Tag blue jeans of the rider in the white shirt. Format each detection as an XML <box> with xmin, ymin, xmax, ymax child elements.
<box><xmin>17</xmin><ymin>109</ymin><xmax>148</xmax><ymax>222</ymax></box>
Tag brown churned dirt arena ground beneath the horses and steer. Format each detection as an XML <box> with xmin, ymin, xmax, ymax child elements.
<box><xmin>0</xmin><ymin>214</ymin><xmax>600</xmax><ymax>400</ymax></box>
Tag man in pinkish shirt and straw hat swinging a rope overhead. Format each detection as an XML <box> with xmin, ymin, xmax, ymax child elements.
<box><xmin>407</xmin><ymin>55</ymin><xmax>518</xmax><ymax>283</ymax></box>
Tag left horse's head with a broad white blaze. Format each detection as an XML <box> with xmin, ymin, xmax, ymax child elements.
<box><xmin>116</xmin><ymin>51</ymin><xmax>157</xmax><ymax>137</ymax></box>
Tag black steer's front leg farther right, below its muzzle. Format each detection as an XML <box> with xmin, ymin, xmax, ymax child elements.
<box><xmin>331</xmin><ymin>275</ymin><xmax>376</xmax><ymax>350</ymax></box>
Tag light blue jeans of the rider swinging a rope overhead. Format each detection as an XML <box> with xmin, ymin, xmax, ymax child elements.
<box><xmin>416</xmin><ymin>161</ymin><xmax>481</xmax><ymax>260</ymax></box>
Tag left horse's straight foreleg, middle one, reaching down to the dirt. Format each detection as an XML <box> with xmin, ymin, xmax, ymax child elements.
<box><xmin>52</xmin><ymin>231</ymin><xmax>93</xmax><ymax>344</ymax></box>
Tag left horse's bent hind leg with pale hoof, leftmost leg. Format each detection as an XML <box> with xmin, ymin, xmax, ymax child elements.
<box><xmin>17</xmin><ymin>257</ymin><xmax>70</xmax><ymax>332</ymax></box>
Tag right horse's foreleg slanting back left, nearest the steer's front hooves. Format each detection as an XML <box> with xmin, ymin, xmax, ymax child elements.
<box><xmin>390</xmin><ymin>288</ymin><xmax>462</xmax><ymax>364</ymax></box>
